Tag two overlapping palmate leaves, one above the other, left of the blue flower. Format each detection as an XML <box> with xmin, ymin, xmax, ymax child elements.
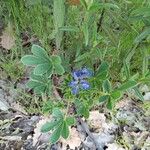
<box><xmin>21</xmin><ymin>45</ymin><xmax>65</xmax><ymax>94</ymax></box>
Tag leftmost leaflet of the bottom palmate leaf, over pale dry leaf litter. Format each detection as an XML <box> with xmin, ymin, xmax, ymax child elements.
<box><xmin>41</xmin><ymin>121</ymin><xmax>60</xmax><ymax>133</ymax></box>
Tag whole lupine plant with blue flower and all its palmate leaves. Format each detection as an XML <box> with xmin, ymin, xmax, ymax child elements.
<box><xmin>21</xmin><ymin>45</ymin><xmax>146</xmax><ymax>144</ymax></box>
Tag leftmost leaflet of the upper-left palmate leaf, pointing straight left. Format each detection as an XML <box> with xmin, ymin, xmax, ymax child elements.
<box><xmin>21</xmin><ymin>55</ymin><xmax>46</xmax><ymax>66</ymax></box>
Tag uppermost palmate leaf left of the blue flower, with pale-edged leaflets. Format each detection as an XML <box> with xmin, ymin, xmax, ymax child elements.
<box><xmin>21</xmin><ymin>45</ymin><xmax>65</xmax><ymax>77</ymax></box>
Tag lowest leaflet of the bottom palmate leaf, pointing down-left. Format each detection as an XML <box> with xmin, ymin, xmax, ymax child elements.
<box><xmin>50</xmin><ymin>123</ymin><xmax>63</xmax><ymax>144</ymax></box>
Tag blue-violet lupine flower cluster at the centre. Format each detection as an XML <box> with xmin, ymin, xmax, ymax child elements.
<box><xmin>69</xmin><ymin>68</ymin><xmax>93</xmax><ymax>95</ymax></box>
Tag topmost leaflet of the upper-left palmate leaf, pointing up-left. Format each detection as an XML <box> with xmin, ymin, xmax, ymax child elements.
<box><xmin>31</xmin><ymin>44</ymin><xmax>49</xmax><ymax>60</ymax></box>
